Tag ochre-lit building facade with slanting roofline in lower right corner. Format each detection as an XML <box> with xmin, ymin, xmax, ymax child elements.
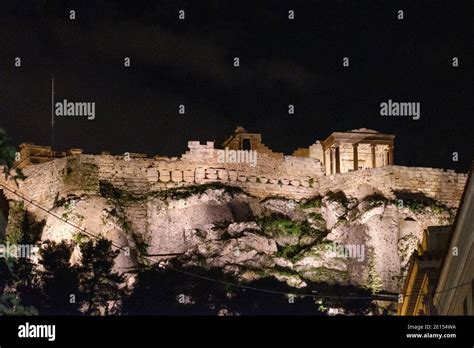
<box><xmin>398</xmin><ymin>162</ymin><xmax>474</xmax><ymax>315</ymax></box>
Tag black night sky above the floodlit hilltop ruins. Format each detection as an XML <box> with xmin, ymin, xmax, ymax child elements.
<box><xmin>0</xmin><ymin>0</ymin><xmax>474</xmax><ymax>172</ymax></box>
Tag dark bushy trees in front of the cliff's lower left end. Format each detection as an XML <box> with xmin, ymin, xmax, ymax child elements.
<box><xmin>15</xmin><ymin>239</ymin><xmax>124</xmax><ymax>315</ymax></box>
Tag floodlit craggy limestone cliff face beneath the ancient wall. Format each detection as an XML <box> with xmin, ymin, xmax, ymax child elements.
<box><xmin>25</xmin><ymin>188</ymin><xmax>450</xmax><ymax>292</ymax></box>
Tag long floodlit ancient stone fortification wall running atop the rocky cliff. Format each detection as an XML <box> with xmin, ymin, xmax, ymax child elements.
<box><xmin>0</xmin><ymin>148</ymin><xmax>467</xmax><ymax>213</ymax></box>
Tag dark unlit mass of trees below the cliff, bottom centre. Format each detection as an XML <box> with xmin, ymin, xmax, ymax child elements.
<box><xmin>123</xmin><ymin>263</ymin><xmax>330</xmax><ymax>315</ymax></box>
